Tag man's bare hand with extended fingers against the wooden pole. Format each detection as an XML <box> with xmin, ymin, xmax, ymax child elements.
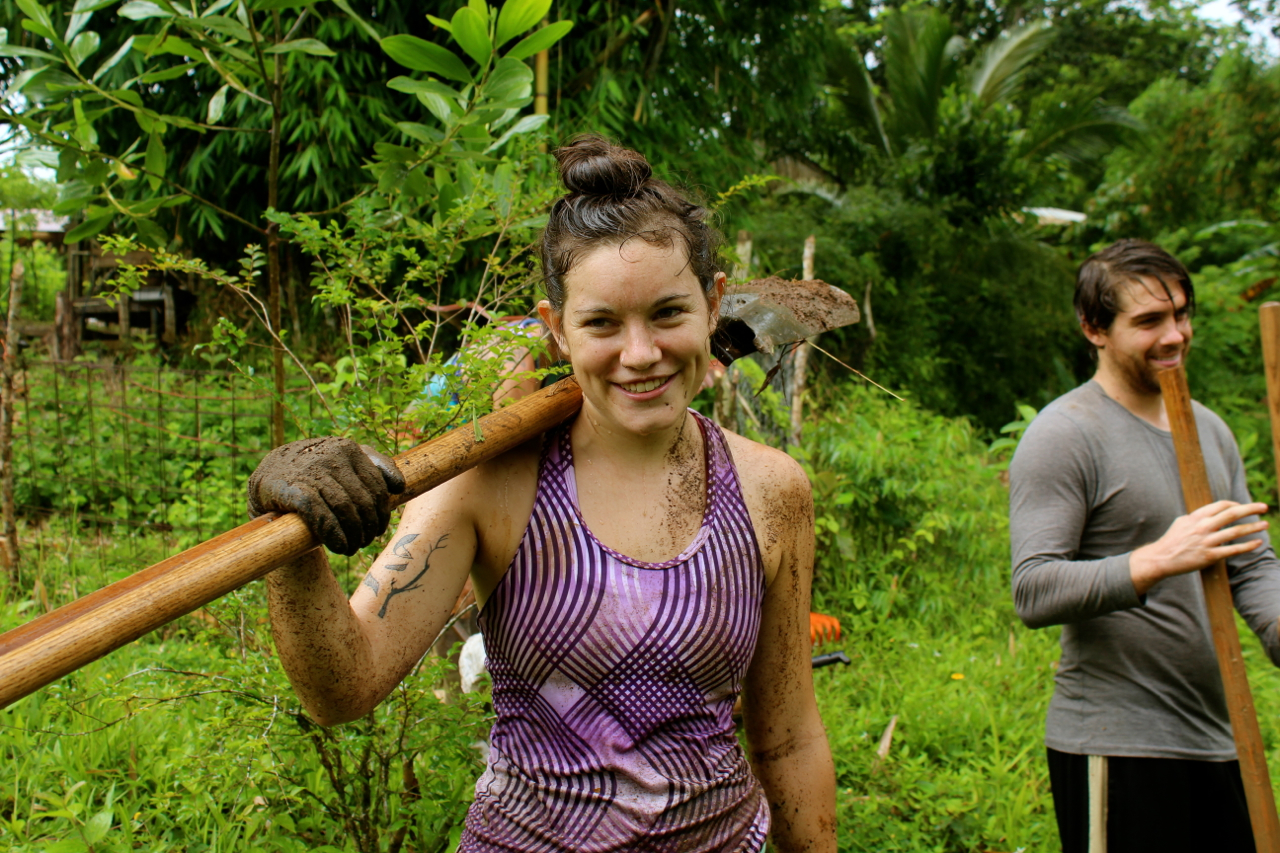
<box><xmin>1129</xmin><ymin>501</ymin><xmax>1267</xmax><ymax>596</ymax></box>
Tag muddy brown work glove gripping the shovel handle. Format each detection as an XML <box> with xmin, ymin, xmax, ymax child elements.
<box><xmin>248</xmin><ymin>435</ymin><xmax>404</xmax><ymax>557</ymax></box>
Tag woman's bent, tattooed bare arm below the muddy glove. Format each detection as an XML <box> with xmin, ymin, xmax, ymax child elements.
<box><xmin>268</xmin><ymin>473</ymin><xmax>476</xmax><ymax>725</ymax></box>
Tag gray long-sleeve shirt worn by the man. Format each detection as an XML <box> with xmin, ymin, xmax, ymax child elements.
<box><xmin>1009</xmin><ymin>382</ymin><xmax>1280</xmax><ymax>761</ymax></box>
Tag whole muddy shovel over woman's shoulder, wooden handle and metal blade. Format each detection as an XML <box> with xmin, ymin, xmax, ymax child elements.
<box><xmin>0</xmin><ymin>279</ymin><xmax>859</xmax><ymax>707</ymax></box>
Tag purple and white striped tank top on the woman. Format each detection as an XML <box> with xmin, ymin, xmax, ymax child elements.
<box><xmin>458</xmin><ymin>411</ymin><xmax>769</xmax><ymax>853</ymax></box>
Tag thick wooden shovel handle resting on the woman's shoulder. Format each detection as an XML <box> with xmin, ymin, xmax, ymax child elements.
<box><xmin>0</xmin><ymin>377</ymin><xmax>582</xmax><ymax>708</ymax></box>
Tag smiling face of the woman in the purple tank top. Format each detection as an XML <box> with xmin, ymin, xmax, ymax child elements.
<box><xmin>539</xmin><ymin>238</ymin><xmax>724</xmax><ymax>435</ymax></box>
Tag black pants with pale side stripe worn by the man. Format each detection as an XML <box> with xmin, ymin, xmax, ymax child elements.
<box><xmin>1048</xmin><ymin>749</ymin><xmax>1254</xmax><ymax>853</ymax></box>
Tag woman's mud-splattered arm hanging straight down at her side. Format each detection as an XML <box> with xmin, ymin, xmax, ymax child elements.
<box><xmin>740</xmin><ymin>445</ymin><xmax>836</xmax><ymax>853</ymax></box>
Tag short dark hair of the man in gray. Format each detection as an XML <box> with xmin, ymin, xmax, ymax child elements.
<box><xmin>1075</xmin><ymin>240</ymin><xmax>1196</xmax><ymax>332</ymax></box>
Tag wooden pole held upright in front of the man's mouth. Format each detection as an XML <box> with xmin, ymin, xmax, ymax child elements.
<box><xmin>1160</xmin><ymin>366</ymin><xmax>1280</xmax><ymax>853</ymax></box>
